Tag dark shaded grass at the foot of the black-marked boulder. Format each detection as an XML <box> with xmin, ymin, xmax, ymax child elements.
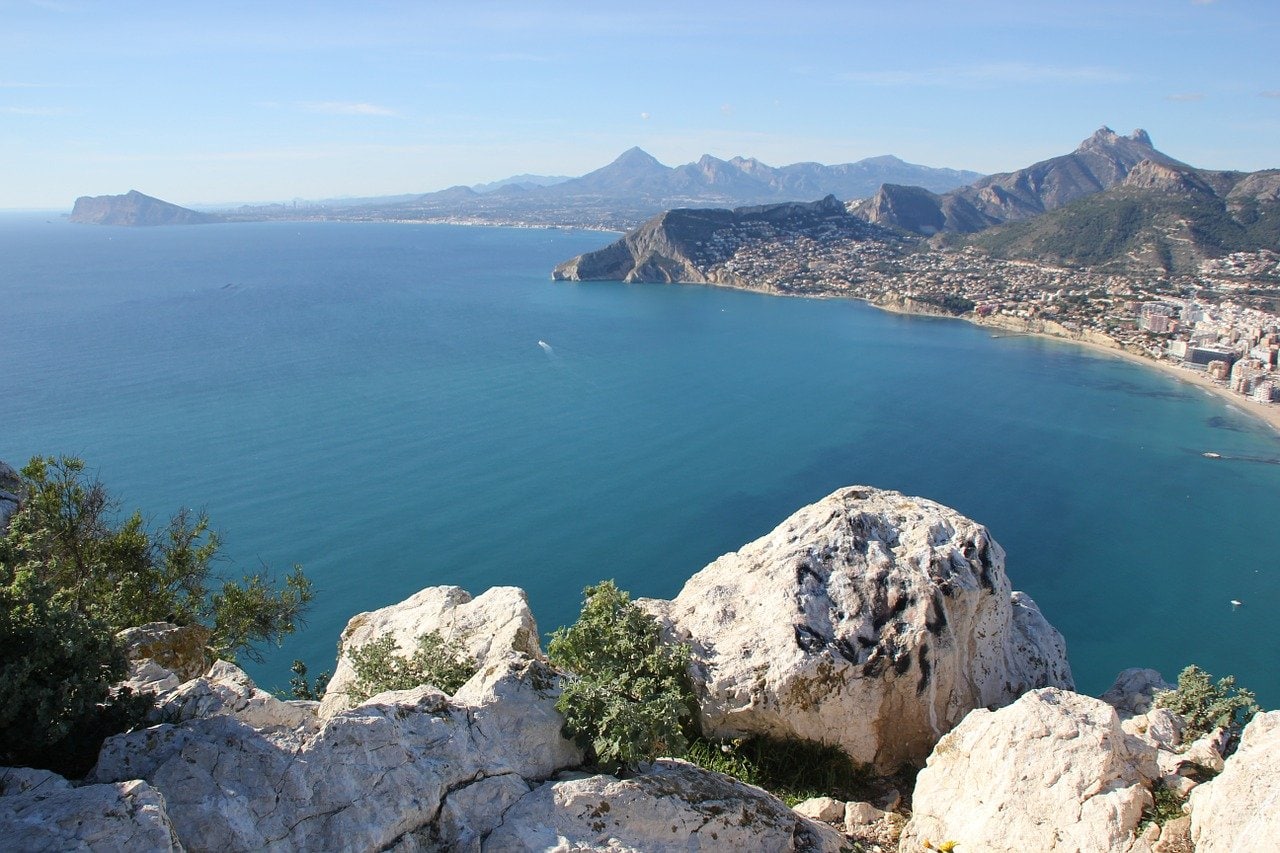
<box><xmin>685</xmin><ymin>738</ymin><xmax>876</xmax><ymax>806</ymax></box>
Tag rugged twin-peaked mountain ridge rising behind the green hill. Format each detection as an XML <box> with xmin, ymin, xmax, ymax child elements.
<box><xmin>851</xmin><ymin>127</ymin><xmax>1172</xmax><ymax>234</ymax></box>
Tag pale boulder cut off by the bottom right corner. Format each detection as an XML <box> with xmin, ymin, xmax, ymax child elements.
<box><xmin>1190</xmin><ymin>711</ymin><xmax>1280</xmax><ymax>853</ymax></box>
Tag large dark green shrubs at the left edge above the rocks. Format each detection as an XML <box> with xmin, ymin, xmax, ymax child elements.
<box><xmin>0</xmin><ymin>456</ymin><xmax>312</xmax><ymax>776</ymax></box>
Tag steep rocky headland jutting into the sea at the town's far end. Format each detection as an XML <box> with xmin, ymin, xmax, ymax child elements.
<box><xmin>552</xmin><ymin>196</ymin><xmax>873</xmax><ymax>283</ymax></box>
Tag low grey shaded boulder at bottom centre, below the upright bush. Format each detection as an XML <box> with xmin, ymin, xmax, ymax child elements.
<box><xmin>481</xmin><ymin>758</ymin><xmax>844</xmax><ymax>853</ymax></box>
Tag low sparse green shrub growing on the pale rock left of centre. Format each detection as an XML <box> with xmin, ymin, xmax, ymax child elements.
<box><xmin>347</xmin><ymin>631</ymin><xmax>476</xmax><ymax>702</ymax></box>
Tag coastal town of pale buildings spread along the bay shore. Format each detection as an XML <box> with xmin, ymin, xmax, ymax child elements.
<box><xmin>698</xmin><ymin>225</ymin><xmax>1280</xmax><ymax>423</ymax></box>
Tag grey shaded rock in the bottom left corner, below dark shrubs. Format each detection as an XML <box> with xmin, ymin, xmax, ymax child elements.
<box><xmin>0</xmin><ymin>767</ymin><xmax>182</xmax><ymax>853</ymax></box>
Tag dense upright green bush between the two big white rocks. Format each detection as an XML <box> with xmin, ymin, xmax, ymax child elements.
<box><xmin>548</xmin><ymin>580</ymin><xmax>694</xmax><ymax>771</ymax></box>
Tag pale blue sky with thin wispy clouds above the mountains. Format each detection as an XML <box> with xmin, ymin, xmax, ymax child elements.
<box><xmin>0</xmin><ymin>0</ymin><xmax>1280</xmax><ymax>210</ymax></box>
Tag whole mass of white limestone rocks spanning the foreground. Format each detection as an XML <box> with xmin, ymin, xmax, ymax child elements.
<box><xmin>0</xmin><ymin>487</ymin><xmax>1280</xmax><ymax>853</ymax></box>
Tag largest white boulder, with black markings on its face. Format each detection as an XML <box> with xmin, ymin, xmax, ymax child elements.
<box><xmin>639</xmin><ymin>487</ymin><xmax>1073</xmax><ymax>771</ymax></box>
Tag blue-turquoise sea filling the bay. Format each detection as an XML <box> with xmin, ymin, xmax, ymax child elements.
<box><xmin>0</xmin><ymin>216</ymin><xmax>1280</xmax><ymax>707</ymax></box>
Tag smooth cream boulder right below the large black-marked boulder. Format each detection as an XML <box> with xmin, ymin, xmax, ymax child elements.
<box><xmin>901</xmin><ymin>688</ymin><xmax>1157</xmax><ymax>853</ymax></box>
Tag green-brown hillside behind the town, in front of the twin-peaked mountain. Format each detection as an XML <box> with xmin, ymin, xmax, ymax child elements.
<box><xmin>964</xmin><ymin>158</ymin><xmax>1280</xmax><ymax>268</ymax></box>
